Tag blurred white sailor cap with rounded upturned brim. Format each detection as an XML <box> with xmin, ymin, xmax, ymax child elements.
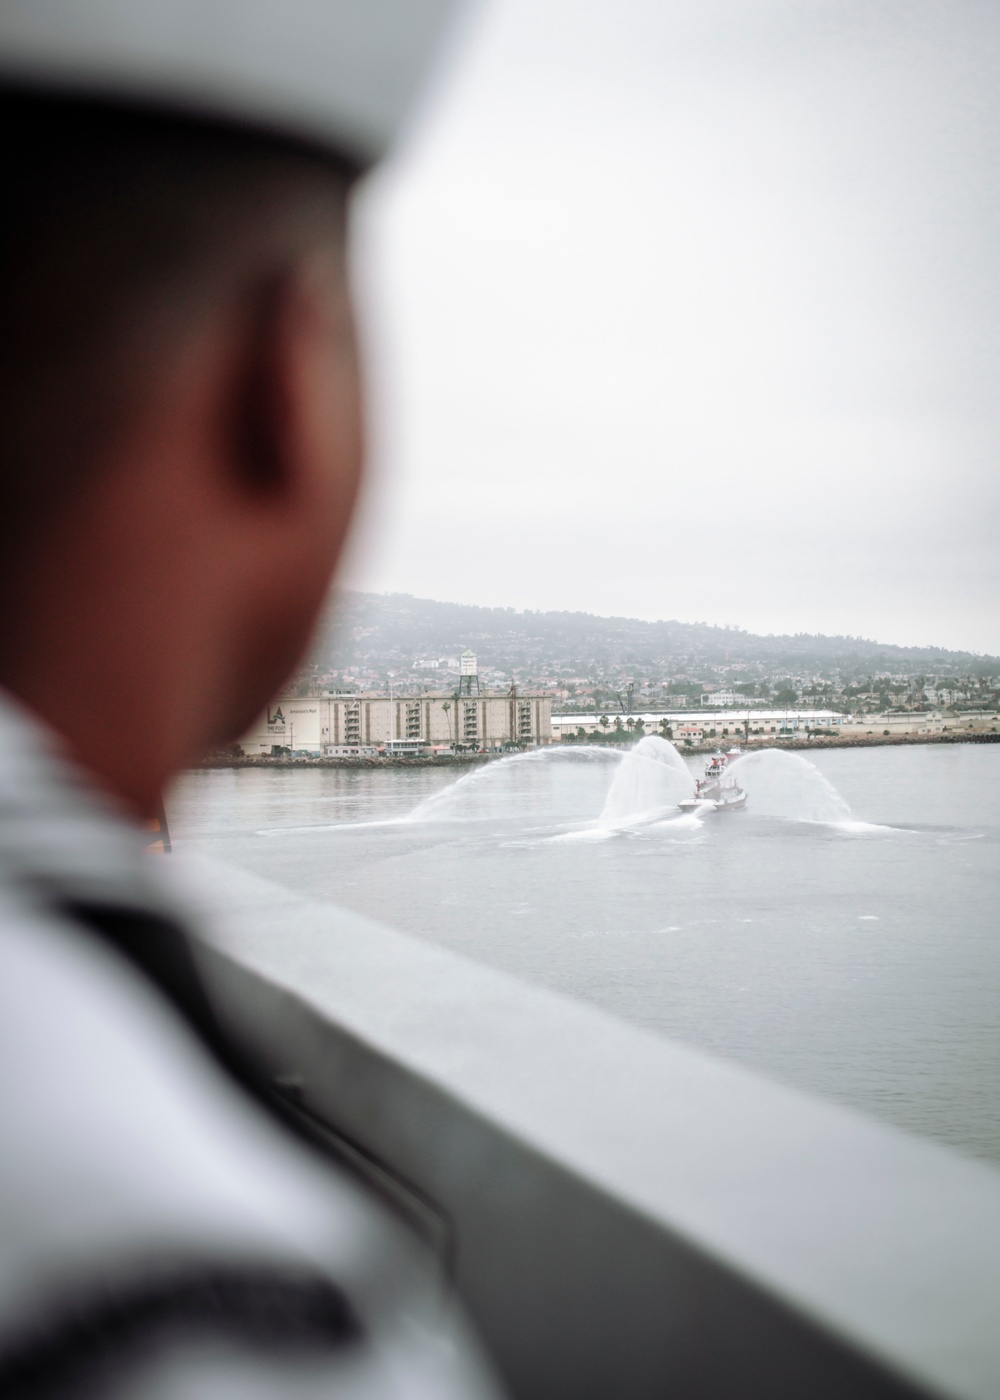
<box><xmin>0</xmin><ymin>0</ymin><xmax>457</xmax><ymax>167</ymax></box>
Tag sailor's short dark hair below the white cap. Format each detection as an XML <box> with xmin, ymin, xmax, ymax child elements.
<box><xmin>0</xmin><ymin>90</ymin><xmax>357</xmax><ymax>567</ymax></box>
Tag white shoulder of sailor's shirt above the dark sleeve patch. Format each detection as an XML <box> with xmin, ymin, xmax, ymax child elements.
<box><xmin>0</xmin><ymin>881</ymin><xmax>386</xmax><ymax>1301</ymax></box>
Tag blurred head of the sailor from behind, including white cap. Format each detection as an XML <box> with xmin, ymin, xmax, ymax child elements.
<box><xmin>0</xmin><ymin>0</ymin><xmax>451</xmax><ymax>805</ymax></box>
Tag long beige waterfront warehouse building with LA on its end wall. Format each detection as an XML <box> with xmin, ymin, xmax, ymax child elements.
<box><xmin>241</xmin><ymin>690</ymin><xmax>552</xmax><ymax>756</ymax></box>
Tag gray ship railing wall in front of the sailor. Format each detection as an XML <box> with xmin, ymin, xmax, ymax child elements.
<box><xmin>184</xmin><ymin>865</ymin><xmax>1000</xmax><ymax>1400</ymax></box>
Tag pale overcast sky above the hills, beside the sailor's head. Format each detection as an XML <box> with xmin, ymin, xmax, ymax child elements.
<box><xmin>340</xmin><ymin>0</ymin><xmax>1000</xmax><ymax>652</ymax></box>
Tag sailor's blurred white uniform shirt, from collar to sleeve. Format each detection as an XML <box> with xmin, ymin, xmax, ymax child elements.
<box><xmin>0</xmin><ymin>699</ymin><xmax>496</xmax><ymax>1400</ymax></box>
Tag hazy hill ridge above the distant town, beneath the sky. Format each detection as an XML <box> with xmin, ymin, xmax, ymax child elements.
<box><xmin>321</xmin><ymin>591</ymin><xmax>1000</xmax><ymax>675</ymax></box>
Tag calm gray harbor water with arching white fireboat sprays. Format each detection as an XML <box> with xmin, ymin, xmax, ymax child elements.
<box><xmin>168</xmin><ymin>739</ymin><xmax>1000</xmax><ymax>1163</ymax></box>
